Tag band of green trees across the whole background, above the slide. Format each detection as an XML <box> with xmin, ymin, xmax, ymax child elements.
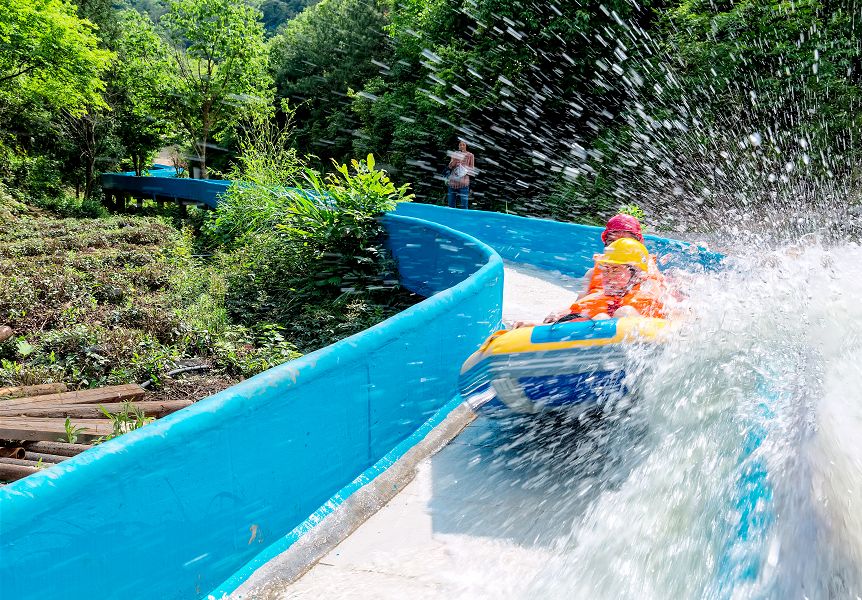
<box><xmin>0</xmin><ymin>0</ymin><xmax>862</xmax><ymax>220</ymax></box>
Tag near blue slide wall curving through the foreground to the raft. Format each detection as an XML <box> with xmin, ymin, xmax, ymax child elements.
<box><xmin>0</xmin><ymin>215</ymin><xmax>503</xmax><ymax>600</ymax></box>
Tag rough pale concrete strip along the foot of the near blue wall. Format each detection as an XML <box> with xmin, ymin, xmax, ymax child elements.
<box><xmin>230</xmin><ymin>402</ymin><xmax>476</xmax><ymax>600</ymax></box>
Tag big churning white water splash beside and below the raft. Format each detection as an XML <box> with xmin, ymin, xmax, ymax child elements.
<box><xmin>436</xmin><ymin>244</ymin><xmax>862</xmax><ymax>599</ymax></box>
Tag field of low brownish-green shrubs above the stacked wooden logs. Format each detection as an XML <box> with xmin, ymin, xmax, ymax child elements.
<box><xmin>0</xmin><ymin>207</ymin><xmax>299</xmax><ymax>387</ymax></box>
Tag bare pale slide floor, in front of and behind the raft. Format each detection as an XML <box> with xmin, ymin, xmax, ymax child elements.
<box><xmin>266</xmin><ymin>264</ymin><xmax>586</xmax><ymax>600</ymax></box>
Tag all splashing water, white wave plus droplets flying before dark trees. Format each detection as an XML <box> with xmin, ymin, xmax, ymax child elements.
<box><xmin>266</xmin><ymin>2</ymin><xmax>862</xmax><ymax>599</ymax></box>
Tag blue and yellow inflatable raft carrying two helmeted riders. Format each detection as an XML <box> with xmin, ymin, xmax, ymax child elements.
<box><xmin>459</xmin><ymin>317</ymin><xmax>670</xmax><ymax>414</ymax></box>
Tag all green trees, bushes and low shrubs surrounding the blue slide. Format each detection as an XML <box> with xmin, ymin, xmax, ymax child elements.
<box><xmin>0</xmin><ymin>0</ymin><xmax>862</xmax><ymax>389</ymax></box>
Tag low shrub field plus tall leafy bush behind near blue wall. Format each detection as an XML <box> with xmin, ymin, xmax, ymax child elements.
<box><xmin>0</xmin><ymin>121</ymin><xmax>416</xmax><ymax>386</ymax></box>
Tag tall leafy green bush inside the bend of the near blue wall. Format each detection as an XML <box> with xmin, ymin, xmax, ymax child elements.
<box><xmin>206</xmin><ymin>117</ymin><xmax>415</xmax><ymax>342</ymax></box>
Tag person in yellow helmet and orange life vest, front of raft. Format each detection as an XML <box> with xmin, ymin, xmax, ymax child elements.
<box><xmin>569</xmin><ymin>238</ymin><xmax>666</xmax><ymax>319</ymax></box>
